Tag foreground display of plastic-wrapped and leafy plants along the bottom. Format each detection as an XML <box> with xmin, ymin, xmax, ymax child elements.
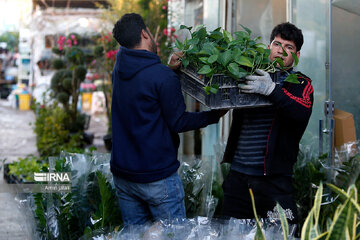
<box><xmin>6</xmin><ymin>141</ymin><xmax>360</xmax><ymax>240</ymax></box>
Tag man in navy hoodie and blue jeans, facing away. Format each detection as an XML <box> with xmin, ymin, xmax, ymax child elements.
<box><xmin>110</xmin><ymin>13</ymin><xmax>225</xmax><ymax>225</ymax></box>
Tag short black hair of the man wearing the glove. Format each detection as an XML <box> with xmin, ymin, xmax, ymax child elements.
<box><xmin>270</xmin><ymin>22</ymin><xmax>304</xmax><ymax>51</ymax></box>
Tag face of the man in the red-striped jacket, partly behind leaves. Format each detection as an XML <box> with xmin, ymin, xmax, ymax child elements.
<box><xmin>268</xmin><ymin>35</ymin><xmax>300</xmax><ymax>67</ymax></box>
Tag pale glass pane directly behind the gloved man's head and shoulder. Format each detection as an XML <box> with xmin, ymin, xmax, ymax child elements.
<box><xmin>292</xmin><ymin>0</ymin><xmax>329</xmax><ymax>149</ymax></box>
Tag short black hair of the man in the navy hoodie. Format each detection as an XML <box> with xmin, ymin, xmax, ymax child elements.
<box><xmin>113</xmin><ymin>13</ymin><xmax>146</xmax><ymax>48</ymax></box>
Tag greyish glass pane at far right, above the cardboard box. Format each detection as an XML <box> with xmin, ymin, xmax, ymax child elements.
<box><xmin>331</xmin><ymin>5</ymin><xmax>360</xmax><ymax>139</ymax></box>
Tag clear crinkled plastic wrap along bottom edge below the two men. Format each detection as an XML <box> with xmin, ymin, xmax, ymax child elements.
<box><xmin>93</xmin><ymin>217</ymin><xmax>295</xmax><ymax>240</ymax></box>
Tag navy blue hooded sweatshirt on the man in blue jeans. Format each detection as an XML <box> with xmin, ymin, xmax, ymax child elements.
<box><xmin>110</xmin><ymin>47</ymin><xmax>219</xmax><ymax>183</ymax></box>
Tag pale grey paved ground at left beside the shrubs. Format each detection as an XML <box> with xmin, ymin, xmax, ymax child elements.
<box><xmin>0</xmin><ymin>99</ymin><xmax>107</xmax><ymax>240</ymax></box>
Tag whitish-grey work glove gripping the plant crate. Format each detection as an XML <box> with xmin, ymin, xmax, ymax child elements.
<box><xmin>239</xmin><ymin>69</ymin><xmax>275</xmax><ymax>96</ymax></box>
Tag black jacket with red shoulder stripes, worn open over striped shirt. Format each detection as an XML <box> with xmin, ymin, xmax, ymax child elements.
<box><xmin>223</xmin><ymin>72</ymin><xmax>314</xmax><ymax>176</ymax></box>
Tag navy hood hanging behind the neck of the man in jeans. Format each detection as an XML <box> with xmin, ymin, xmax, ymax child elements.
<box><xmin>114</xmin><ymin>47</ymin><xmax>161</xmax><ymax>80</ymax></box>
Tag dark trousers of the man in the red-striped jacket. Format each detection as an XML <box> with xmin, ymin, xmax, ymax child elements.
<box><xmin>222</xmin><ymin>171</ymin><xmax>297</xmax><ymax>224</ymax></box>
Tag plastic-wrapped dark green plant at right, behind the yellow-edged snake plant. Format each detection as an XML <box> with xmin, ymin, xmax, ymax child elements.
<box><xmin>293</xmin><ymin>141</ymin><xmax>360</xmax><ymax>232</ymax></box>
